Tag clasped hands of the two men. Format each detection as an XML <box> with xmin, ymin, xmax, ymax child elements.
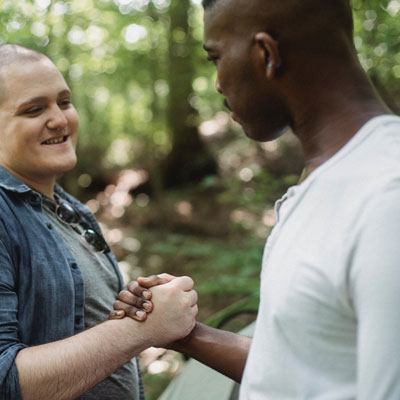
<box><xmin>109</xmin><ymin>273</ymin><xmax>198</xmax><ymax>347</ymax></box>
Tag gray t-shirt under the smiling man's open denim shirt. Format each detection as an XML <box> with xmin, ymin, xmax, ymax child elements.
<box><xmin>42</xmin><ymin>196</ymin><xmax>140</xmax><ymax>400</ymax></box>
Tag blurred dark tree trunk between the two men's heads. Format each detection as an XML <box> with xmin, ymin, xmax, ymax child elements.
<box><xmin>163</xmin><ymin>0</ymin><xmax>217</xmax><ymax>187</ymax></box>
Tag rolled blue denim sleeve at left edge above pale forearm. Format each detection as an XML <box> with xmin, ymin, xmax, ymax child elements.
<box><xmin>0</xmin><ymin>240</ymin><xmax>27</xmax><ymax>400</ymax></box>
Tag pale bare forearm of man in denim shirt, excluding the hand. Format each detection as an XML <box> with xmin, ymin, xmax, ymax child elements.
<box><xmin>16</xmin><ymin>318</ymin><xmax>150</xmax><ymax>400</ymax></box>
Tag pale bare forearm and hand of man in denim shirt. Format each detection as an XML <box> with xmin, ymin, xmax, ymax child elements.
<box><xmin>16</xmin><ymin>277</ymin><xmax>197</xmax><ymax>400</ymax></box>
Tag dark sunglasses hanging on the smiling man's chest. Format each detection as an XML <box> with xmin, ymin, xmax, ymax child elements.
<box><xmin>56</xmin><ymin>201</ymin><xmax>110</xmax><ymax>253</ymax></box>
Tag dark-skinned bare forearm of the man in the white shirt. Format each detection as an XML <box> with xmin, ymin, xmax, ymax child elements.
<box><xmin>172</xmin><ymin>322</ymin><xmax>251</xmax><ymax>382</ymax></box>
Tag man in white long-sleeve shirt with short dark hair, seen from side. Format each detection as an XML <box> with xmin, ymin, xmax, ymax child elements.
<box><xmin>116</xmin><ymin>0</ymin><xmax>400</xmax><ymax>400</ymax></box>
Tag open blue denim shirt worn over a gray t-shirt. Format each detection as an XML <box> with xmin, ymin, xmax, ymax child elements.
<box><xmin>0</xmin><ymin>166</ymin><xmax>141</xmax><ymax>400</ymax></box>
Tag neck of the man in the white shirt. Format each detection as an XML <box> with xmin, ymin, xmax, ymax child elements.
<box><xmin>284</xmin><ymin>46</ymin><xmax>391</xmax><ymax>171</ymax></box>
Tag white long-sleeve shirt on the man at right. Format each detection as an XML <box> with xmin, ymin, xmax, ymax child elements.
<box><xmin>240</xmin><ymin>116</ymin><xmax>400</xmax><ymax>400</ymax></box>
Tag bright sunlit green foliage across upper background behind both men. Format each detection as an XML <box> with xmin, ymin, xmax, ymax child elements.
<box><xmin>0</xmin><ymin>0</ymin><xmax>400</xmax><ymax>186</ymax></box>
